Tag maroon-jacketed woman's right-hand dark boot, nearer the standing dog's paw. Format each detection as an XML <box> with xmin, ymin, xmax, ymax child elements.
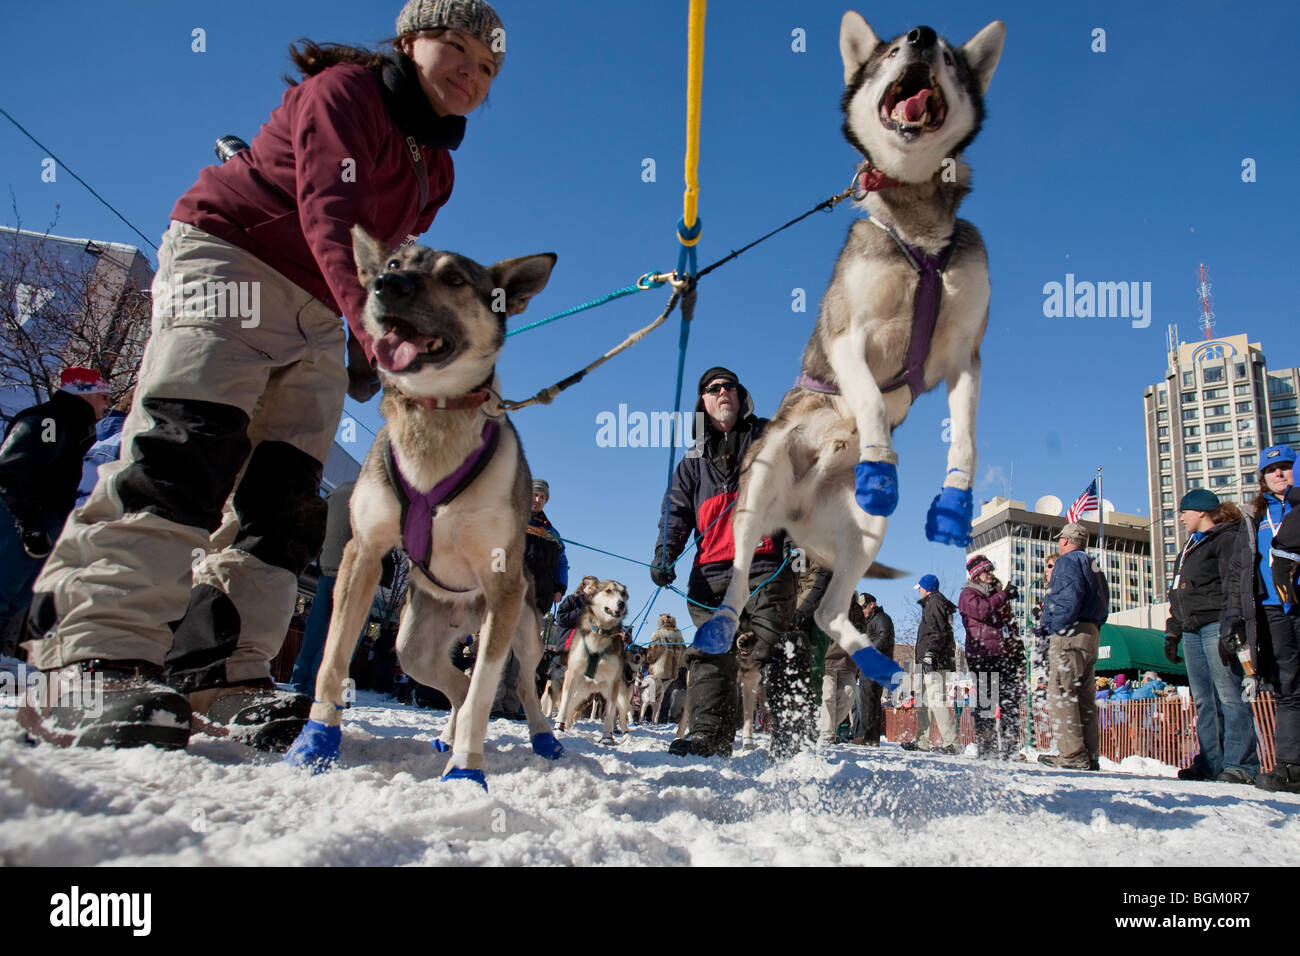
<box><xmin>190</xmin><ymin>679</ymin><xmax>312</xmax><ymax>753</ymax></box>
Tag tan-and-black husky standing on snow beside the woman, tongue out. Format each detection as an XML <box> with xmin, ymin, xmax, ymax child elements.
<box><xmin>286</xmin><ymin>226</ymin><xmax>563</xmax><ymax>788</ymax></box>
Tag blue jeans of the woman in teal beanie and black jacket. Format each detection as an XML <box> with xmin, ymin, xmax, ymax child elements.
<box><xmin>1182</xmin><ymin>629</ymin><xmax>1260</xmax><ymax>777</ymax></box>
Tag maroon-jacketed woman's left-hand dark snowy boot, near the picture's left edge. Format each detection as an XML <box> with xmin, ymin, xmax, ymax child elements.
<box><xmin>18</xmin><ymin>661</ymin><xmax>190</xmax><ymax>750</ymax></box>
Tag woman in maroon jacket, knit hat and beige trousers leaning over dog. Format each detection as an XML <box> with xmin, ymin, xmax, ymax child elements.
<box><xmin>20</xmin><ymin>0</ymin><xmax>504</xmax><ymax>749</ymax></box>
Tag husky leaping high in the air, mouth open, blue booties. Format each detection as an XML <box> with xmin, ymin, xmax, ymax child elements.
<box><xmin>696</xmin><ymin>10</ymin><xmax>1005</xmax><ymax>685</ymax></box>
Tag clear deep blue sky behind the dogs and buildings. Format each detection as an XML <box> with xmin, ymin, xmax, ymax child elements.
<box><xmin>0</xmin><ymin>0</ymin><xmax>1300</xmax><ymax>640</ymax></box>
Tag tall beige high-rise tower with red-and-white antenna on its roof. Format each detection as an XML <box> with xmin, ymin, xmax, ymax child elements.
<box><xmin>1143</xmin><ymin>329</ymin><xmax>1300</xmax><ymax>601</ymax></box>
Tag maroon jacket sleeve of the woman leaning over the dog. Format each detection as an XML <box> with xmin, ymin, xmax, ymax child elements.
<box><xmin>291</xmin><ymin>69</ymin><xmax>394</xmax><ymax>359</ymax></box>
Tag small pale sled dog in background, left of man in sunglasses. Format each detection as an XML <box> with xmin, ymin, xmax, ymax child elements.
<box><xmin>559</xmin><ymin>581</ymin><xmax>631</xmax><ymax>744</ymax></box>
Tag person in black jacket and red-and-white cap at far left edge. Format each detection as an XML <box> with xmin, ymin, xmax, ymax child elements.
<box><xmin>0</xmin><ymin>367</ymin><xmax>109</xmax><ymax>639</ymax></box>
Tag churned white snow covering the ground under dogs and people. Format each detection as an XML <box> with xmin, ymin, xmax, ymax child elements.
<box><xmin>0</xmin><ymin>693</ymin><xmax>1300</xmax><ymax>866</ymax></box>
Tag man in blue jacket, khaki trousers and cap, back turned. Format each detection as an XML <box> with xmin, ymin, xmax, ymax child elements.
<box><xmin>1035</xmin><ymin>524</ymin><xmax>1110</xmax><ymax>770</ymax></box>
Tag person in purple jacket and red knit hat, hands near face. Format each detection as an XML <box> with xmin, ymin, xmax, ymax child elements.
<box><xmin>957</xmin><ymin>554</ymin><xmax>1024</xmax><ymax>760</ymax></box>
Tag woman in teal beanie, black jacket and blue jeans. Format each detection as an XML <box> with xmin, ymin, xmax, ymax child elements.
<box><xmin>1164</xmin><ymin>488</ymin><xmax>1260</xmax><ymax>783</ymax></box>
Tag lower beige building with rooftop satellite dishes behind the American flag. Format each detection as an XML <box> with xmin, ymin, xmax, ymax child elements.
<box><xmin>953</xmin><ymin>497</ymin><xmax>1156</xmax><ymax>623</ymax></box>
